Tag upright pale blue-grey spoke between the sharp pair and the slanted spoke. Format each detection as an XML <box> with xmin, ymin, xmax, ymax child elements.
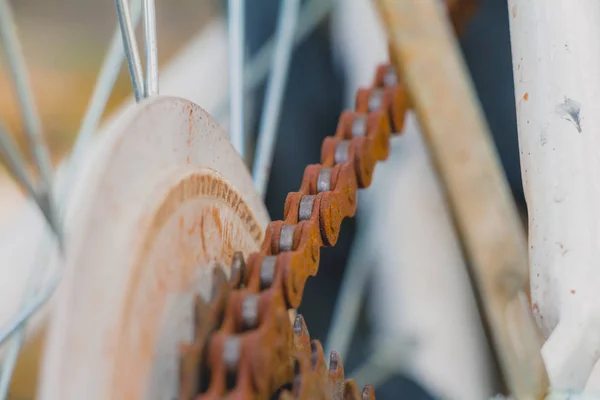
<box><xmin>227</xmin><ymin>0</ymin><xmax>245</xmax><ymax>158</ymax></box>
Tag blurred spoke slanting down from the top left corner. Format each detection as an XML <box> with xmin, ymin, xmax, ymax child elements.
<box><xmin>0</xmin><ymin>0</ymin><xmax>60</xmax><ymax>228</ymax></box>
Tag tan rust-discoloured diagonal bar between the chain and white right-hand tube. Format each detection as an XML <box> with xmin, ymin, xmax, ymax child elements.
<box><xmin>378</xmin><ymin>0</ymin><xmax>548</xmax><ymax>399</ymax></box>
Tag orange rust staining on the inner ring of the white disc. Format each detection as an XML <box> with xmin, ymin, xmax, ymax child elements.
<box><xmin>109</xmin><ymin>170</ymin><xmax>262</xmax><ymax>398</ymax></box>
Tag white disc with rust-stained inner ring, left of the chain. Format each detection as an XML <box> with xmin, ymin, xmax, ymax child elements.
<box><xmin>38</xmin><ymin>96</ymin><xmax>269</xmax><ymax>399</ymax></box>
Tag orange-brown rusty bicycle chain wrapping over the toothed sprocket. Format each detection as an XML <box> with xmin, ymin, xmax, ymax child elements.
<box><xmin>179</xmin><ymin>0</ymin><xmax>476</xmax><ymax>400</ymax></box>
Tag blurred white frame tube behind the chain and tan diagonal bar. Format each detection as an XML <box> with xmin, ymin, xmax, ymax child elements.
<box><xmin>334</xmin><ymin>0</ymin><xmax>495</xmax><ymax>400</ymax></box>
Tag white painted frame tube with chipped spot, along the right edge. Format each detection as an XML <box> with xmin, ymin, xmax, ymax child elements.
<box><xmin>508</xmin><ymin>0</ymin><xmax>600</xmax><ymax>389</ymax></box>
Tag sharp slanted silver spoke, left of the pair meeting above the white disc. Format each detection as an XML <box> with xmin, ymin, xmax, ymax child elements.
<box><xmin>115</xmin><ymin>0</ymin><xmax>145</xmax><ymax>102</ymax></box>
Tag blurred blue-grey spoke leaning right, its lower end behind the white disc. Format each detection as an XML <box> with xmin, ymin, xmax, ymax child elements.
<box><xmin>252</xmin><ymin>0</ymin><xmax>300</xmax><ymax>197</ymax></box>
